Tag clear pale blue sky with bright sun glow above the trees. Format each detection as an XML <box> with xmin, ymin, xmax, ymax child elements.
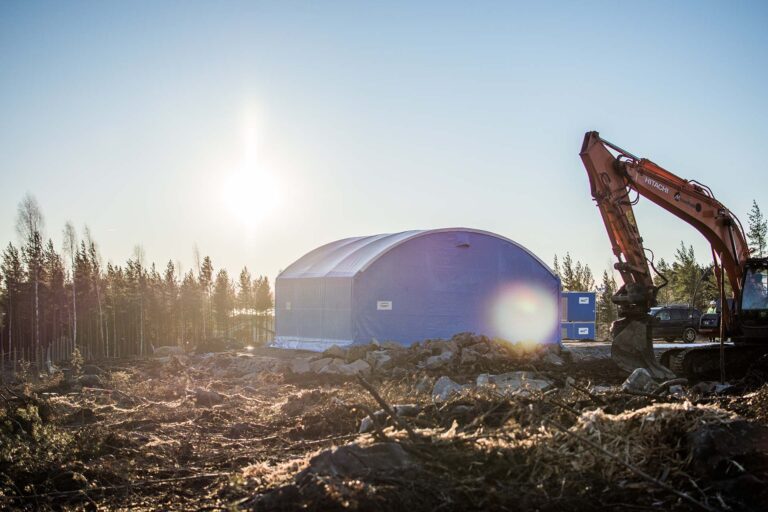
<box><xmin>0</xmin><ymin>0</ymin><xmax>768</xmax><ymax>279</ymax></box>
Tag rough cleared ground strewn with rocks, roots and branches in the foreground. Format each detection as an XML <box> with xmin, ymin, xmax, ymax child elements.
<box><xmin>0</xmin><ymin>334</ymin><xmax>768</xmax><ymax>511</ymax></box>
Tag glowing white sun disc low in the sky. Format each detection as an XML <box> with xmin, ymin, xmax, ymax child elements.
<box><xmin>222</xmin><ymin>169</ymin><xmax>280</xmax><ymax>227</ymax></box>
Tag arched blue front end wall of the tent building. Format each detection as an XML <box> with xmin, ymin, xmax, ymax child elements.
<box><xmin>352</xmin><ymin>232</ymin><xmax>560</xmax><ymax>344</ymax></box>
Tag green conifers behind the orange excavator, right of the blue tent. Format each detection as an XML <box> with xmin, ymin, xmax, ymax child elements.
<box><xmin>554</xmin><ymin>200</ymin><xmax>768</xmax><ymax>335</ymax></box>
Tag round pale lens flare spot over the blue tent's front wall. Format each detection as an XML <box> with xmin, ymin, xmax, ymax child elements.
<box><xmin>490</xmin><ymin>283</ymin><xmax>559</xmax><ymax>344</ymax></box>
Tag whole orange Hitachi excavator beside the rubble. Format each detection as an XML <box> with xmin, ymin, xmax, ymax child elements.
<box><xmin>579</xmin><ymin>131</ymin><xmax>768</xmax><ymax>380</ymax></box>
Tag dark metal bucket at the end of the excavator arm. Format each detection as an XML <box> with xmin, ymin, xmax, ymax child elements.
<box><xmin>611</xmin><ymin>320</ymin><xmax>675</xmax><ymax>380</ymax></box>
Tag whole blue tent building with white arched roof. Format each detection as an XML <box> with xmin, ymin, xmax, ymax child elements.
<box><xmin>275</xmin><ymin>228</ymin><xmax>560</xmax><ymax>350</ymax></box>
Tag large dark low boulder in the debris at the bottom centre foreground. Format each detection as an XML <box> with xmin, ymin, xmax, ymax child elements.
<box><xmin>296</xmin><ymin>443</ymin><xmax>416</xmax><ymax>482</ymax></box>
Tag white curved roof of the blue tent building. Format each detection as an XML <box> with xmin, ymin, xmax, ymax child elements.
<box><xmin>277</xmin><ymin>228</ymin><xmax>554</xmax><ymax>279</ymax></box>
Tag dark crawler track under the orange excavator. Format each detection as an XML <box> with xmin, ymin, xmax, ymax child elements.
<box><xmin>660</xmin><ymin>344</ymin><xmax>768</xmax><ymax>381</ymax></box>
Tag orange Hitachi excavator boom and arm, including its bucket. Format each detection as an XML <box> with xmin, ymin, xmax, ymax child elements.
<box><xmin>579</xmin><ymin>132</ymin><xmax>749</xmax><ymax>378</ymax></box>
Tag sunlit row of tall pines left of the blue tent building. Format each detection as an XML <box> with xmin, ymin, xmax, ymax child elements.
<box><xmin>0</xmin><ymin>195</ymin><xmax>273</xmax><ymax>365</ymax></box>
